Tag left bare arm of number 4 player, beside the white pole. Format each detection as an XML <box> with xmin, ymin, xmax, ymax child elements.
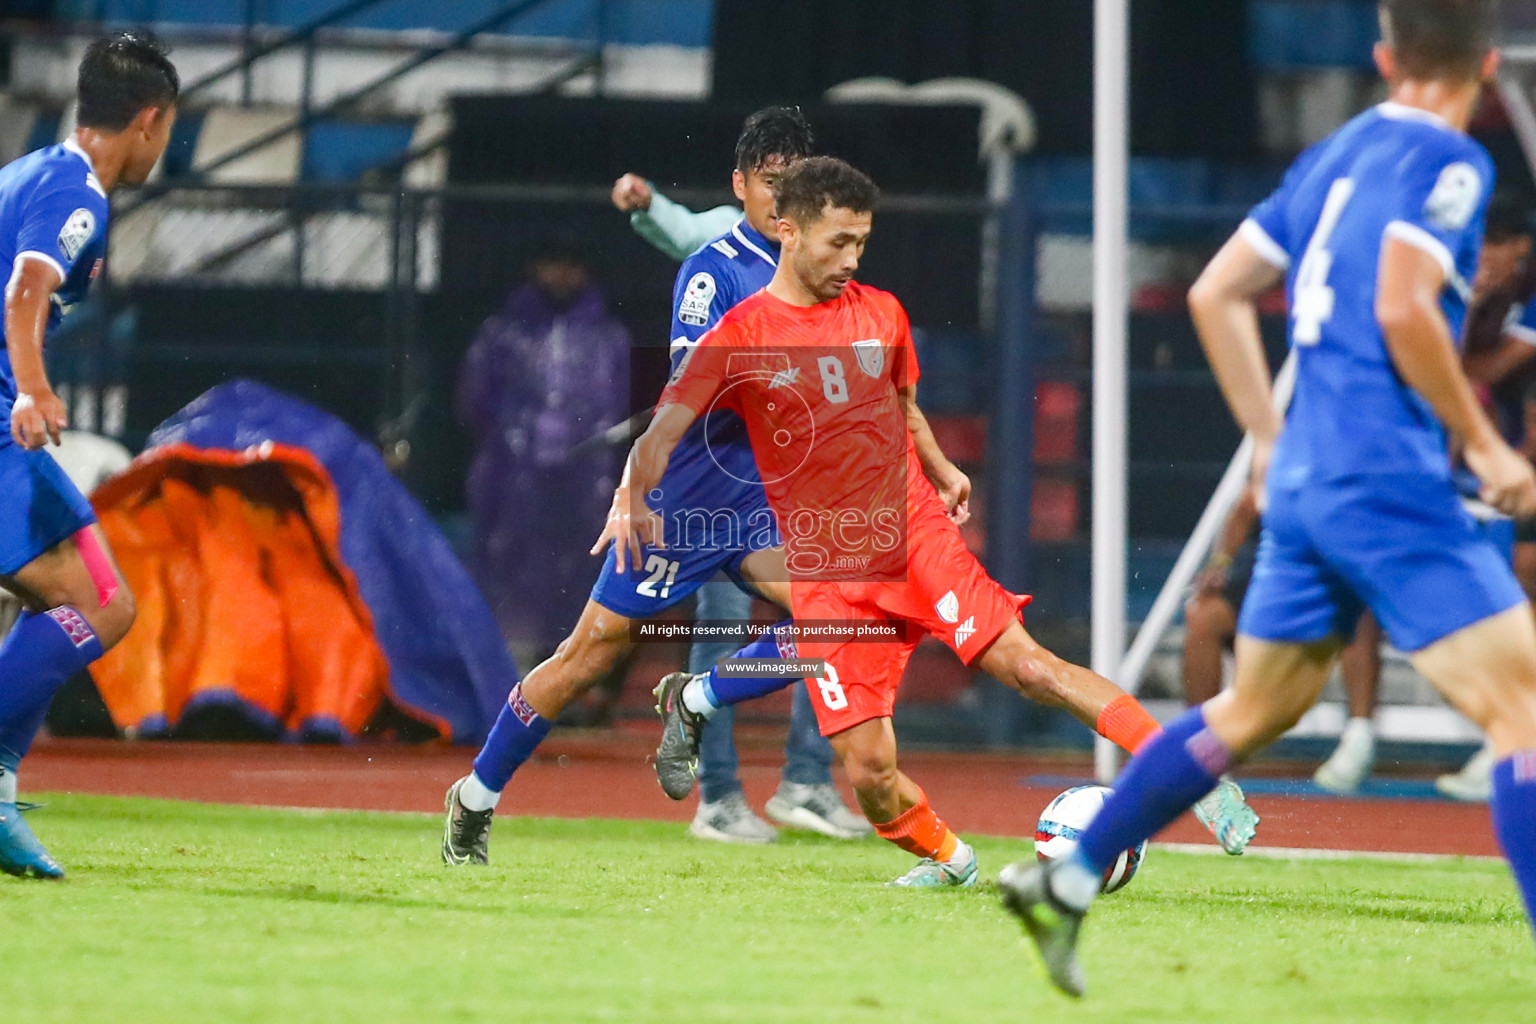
<box><xmin>1189</xmin><ymin>232</ymin><xmax>1283</xmax><ymax>500</ymax></box>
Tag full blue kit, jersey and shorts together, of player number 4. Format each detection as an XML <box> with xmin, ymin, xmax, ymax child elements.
<box><xmin>1238</xmin><ymin>103</ymin><xmax>1525</xmax><ymax>652</ymax></box>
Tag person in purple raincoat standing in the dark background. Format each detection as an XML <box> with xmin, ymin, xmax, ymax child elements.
<box><xmin>455</xmin><ymin>239</ymin><xmax>630</xmax><ymax>660</ymax></box>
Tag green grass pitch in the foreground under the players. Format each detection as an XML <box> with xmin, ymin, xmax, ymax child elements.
<box><xmin>0</xmin><ymin>797</ymin><xmax>1536</xmax><ymax>1024</ymax></box>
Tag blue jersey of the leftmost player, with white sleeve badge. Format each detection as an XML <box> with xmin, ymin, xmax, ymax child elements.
<box><xmin>0</xmin><ymin>140</ymin><xmax>108</xmax><ymax>410</ymax></box>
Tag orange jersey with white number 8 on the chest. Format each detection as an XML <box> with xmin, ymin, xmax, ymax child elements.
<box><xmin>660</xmin><ymin>282</ymin><xmax>945</xmax><ymax>580</ymax></box>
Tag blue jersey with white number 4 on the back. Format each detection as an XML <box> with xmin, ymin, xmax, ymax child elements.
<box><xmin>1241</xmin><ymin>103</ymin><xmax>1493</xmax><ymax>487</ymax></box>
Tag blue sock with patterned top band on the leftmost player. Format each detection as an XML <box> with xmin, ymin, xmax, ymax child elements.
<box><xmin>0</xmin><ymin>605</ymin><xmax>101</xmax><ymax>771</ymax></box>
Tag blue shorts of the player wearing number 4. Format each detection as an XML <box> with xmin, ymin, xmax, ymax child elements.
<box><xmin>1238</xmin><ymin>474</ymin><xmax>1525</xmax><ymax>652</ymax></box>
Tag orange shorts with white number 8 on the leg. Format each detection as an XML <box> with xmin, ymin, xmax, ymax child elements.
<box><xmin>791</xmin><ymin>519</ymin><xmax>1031</xmax><ymax>735</ymax></box>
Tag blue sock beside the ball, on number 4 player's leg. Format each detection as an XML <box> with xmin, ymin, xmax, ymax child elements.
<box><xmin>1077</xmin><ymin>708</ymin><xmax>1232</xmax><ymax>875</ymax></box>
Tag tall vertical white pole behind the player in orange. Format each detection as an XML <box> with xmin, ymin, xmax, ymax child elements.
<box><xmin>1092</xmin><ymin>0</ymin><xmax>1130</xmax><ymax>777</ymax></box>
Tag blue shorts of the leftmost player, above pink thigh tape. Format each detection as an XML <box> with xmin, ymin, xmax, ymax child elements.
<box><xmin>0</xmin><ymin>432</ymin><xmax>95</xmax><ymax>576</ymax></box>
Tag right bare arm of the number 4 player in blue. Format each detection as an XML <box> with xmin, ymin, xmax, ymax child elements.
<box><xmin>1376</xmin><ymin>238</ymin><xmax>1536</xmax><ymax>517</ymax></box>
